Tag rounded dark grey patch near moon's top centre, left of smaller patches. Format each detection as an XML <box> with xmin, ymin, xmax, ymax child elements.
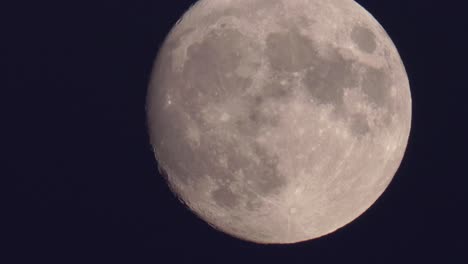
<box><xmin>266</xmin><ymin>29</ymin><xmax>316</xmax><ymax>72</ymax></box>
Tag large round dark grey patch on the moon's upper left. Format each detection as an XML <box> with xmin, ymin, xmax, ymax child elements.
<box><xmin>182</xmin><ymin>29</ymin><xmax>259</xmax><ymax>103</ymax></box>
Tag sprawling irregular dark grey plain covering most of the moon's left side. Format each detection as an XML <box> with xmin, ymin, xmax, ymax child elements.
<box><xmin>149</xmin><ymin>24</ymin><xmax>287</xmax><ymax>209</ymax></box>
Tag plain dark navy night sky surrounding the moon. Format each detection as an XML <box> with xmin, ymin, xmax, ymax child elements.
<box><xmin>0</xmin><ymin>0</ymin><xmax>468</xmax><ymax>263</ymax></box>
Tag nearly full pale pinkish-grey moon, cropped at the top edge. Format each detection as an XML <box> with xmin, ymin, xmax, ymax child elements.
<box><xmin>146</xmin><ymin>0</ymin><xmax>411</xmax><ymax>244</ymax></box>
